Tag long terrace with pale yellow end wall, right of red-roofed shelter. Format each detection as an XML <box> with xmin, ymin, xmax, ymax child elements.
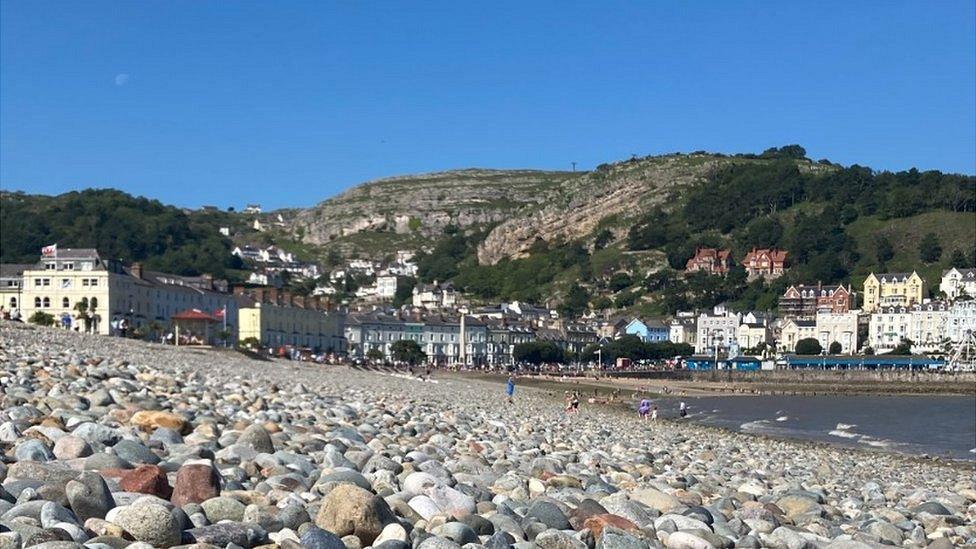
<box><xmin>235</xmin><ymin>288</ymin><xmax>345</xmax><ymax>352</ymax></box>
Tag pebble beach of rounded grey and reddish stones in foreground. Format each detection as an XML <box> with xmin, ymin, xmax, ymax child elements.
<box><xmin>0</xmin><ymin>323</ymin><xmax>976</xmax><ymax>549</ymax></box>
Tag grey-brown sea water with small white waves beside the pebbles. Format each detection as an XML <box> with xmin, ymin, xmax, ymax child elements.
<box><xmin>654</xmin><ymin>395</ymin><xmax>976</xmax><ymax>461</ymax></box>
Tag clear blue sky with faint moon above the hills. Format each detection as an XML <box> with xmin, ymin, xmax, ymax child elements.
<box><xmin>0</xmin><ymin>0</ymin><xmax>976</xmax><ymax>207</ymax></box>
